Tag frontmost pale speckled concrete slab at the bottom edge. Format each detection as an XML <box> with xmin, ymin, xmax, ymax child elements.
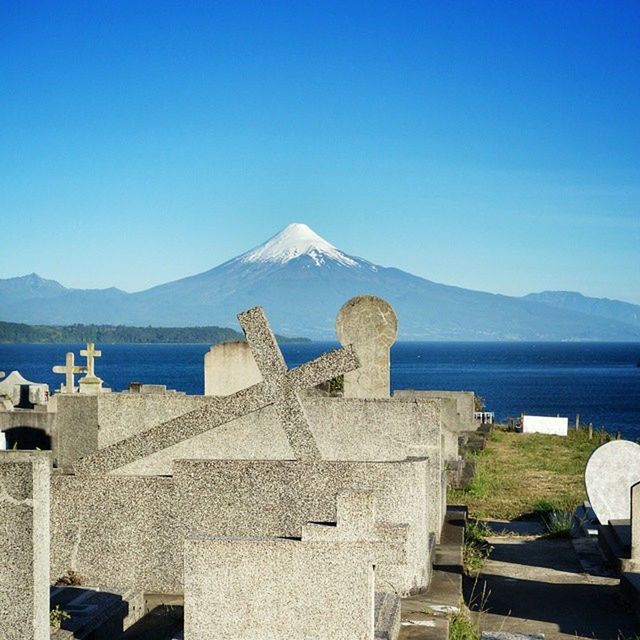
<box><xmin>185</xmin><ymin>539</ymin><xmax>375</xmax><ymax>640</ymax></box>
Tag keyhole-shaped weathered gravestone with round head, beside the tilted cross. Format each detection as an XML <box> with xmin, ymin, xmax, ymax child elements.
<box><xmin>336</xmin><ymin>296</ymin><xmax>398</xmax><ymax>398</ymax></box>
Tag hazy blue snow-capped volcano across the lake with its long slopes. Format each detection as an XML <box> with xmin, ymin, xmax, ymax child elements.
<box><xmin>0</xmin><ymin>223</ymin><xmax>640</xmax><ymax>341</ymax></box>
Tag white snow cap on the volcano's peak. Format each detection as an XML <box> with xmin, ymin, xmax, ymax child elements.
<box><xmin>240</xmin><ymin>222</ymin><xmax>358</xmax><ymax>267</ymax></box>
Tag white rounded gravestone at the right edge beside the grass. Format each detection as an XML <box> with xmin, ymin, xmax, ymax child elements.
<box><xmin>584</xmin><ymin>440</ymin><xmax>640</xmax><ymax>524</ymax></box>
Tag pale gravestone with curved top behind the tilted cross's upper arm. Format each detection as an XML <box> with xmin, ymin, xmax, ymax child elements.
<box><xmin>204</xmin><ymin>342</ymin><xmax>262</xmax><ymax>396</ymax></box>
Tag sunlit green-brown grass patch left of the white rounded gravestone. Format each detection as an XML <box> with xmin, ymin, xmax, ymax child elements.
<box><xmin>449</xmin><ymin>429</ymin><xmax>608</xmax><ymax>519</ymax></box>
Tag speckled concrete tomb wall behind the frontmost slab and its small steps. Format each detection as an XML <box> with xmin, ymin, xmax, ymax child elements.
<box><xmin>174</xmin><ymin>458</ymin><xmax>430</xmax><ymax>595</ymax></box>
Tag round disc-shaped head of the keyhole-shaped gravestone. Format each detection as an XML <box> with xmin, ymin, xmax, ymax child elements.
<box><xmin>336</xmin><ymin>296</ymin><xmax>398</xmax><ymax>347</ymax></box>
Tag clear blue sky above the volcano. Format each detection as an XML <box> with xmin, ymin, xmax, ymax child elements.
<box><xmin>0</xmin><ymin>0</ymin><xmax>640</xmax><ymax>303</ymax></box>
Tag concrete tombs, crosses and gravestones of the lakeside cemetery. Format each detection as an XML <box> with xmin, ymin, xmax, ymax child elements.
<box><xmin>0</xmin><ymin>296</ymin><xmax>640</xmax><ymax>640</ymax></box>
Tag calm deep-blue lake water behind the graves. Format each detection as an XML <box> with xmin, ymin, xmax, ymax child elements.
<box><xmin>0</xmin><ymin>342</ymin><xmax>640</xmax><ymax>439</ymax></box>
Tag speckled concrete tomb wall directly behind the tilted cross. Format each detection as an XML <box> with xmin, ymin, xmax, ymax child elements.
<box><xmin>54</xmin><ymin>394</ymin><xmax>448</xmax><ymax>475</ymax></box>
